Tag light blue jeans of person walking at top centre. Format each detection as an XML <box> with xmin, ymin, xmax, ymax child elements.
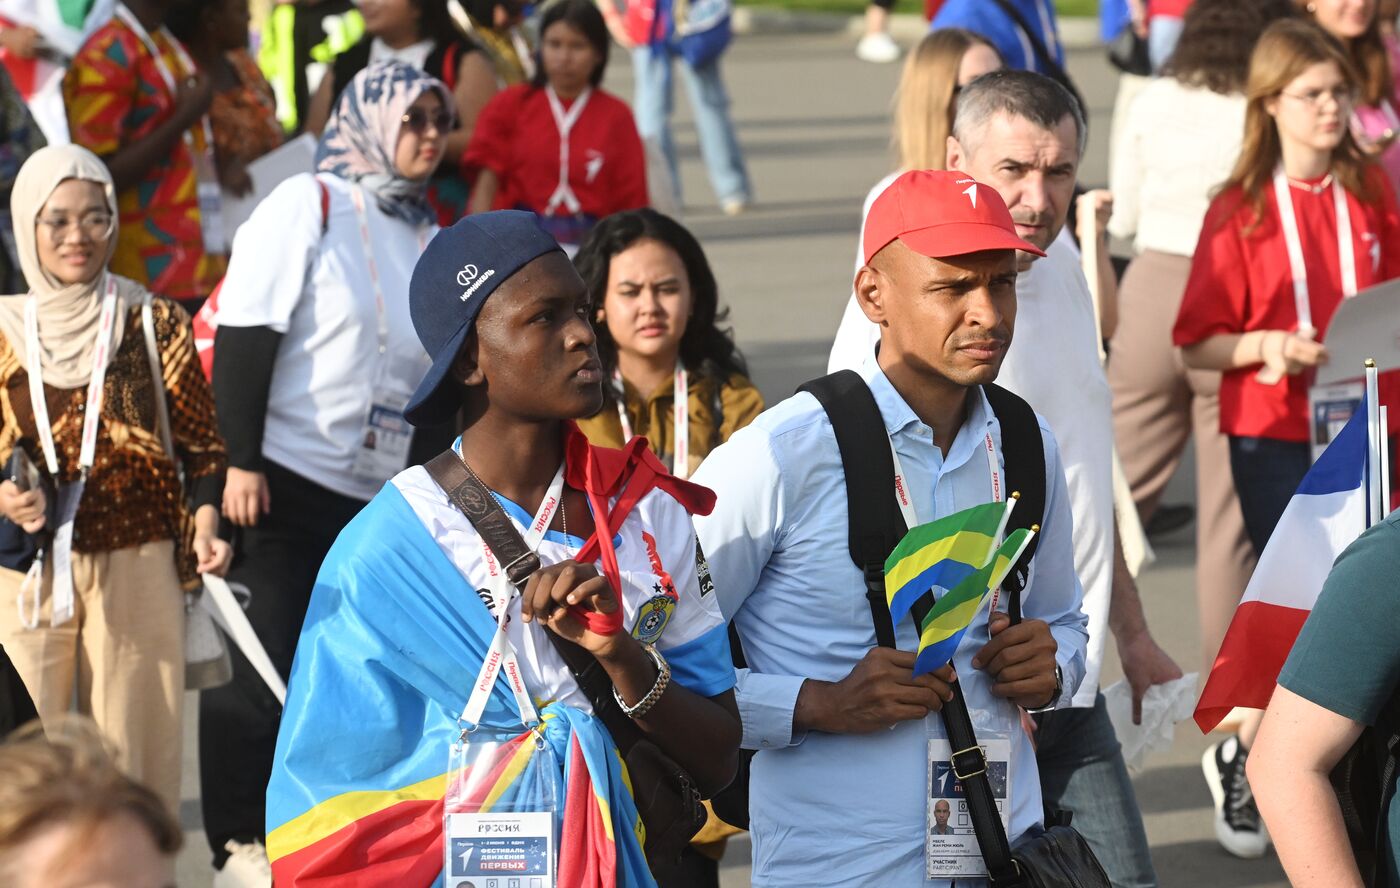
<box><xmin>631</xmin><ymin>46</ymin><xmax>752</xmax><ymax>206</ymax></box>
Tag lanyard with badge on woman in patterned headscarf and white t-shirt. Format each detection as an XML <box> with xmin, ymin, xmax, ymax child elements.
<box><xmin>350</xmin><ymin>185</ymin><xmax>424</xmax><ymax>482</ymax></box>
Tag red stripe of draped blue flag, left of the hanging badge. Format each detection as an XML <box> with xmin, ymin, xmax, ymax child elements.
<box><xmin>272</xmin><ymin>798</ymin><xmax>442</xmax><ymax>888</ymax></box>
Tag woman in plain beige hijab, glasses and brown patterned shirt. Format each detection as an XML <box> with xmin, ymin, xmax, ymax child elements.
<box><xmin>0</xmin><ymin>146</ymin><xmax>230</xmax><ymax>810</ymax></box>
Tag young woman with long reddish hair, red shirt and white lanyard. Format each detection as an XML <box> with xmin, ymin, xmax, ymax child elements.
<box><xmin>1173</xmin><ymin>20</ymin><xmax>1400</xmax><ymax>550</ymax></box>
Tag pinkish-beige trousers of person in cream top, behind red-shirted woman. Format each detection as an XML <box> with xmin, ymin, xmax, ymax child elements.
<box><xmin>1109</xmin><ymin>251</ymin><xmax>1254</xmax><ymax>677</ymax></box>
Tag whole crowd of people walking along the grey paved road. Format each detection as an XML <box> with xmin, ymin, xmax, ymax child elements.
<box><xmin>0</xmin><ymin>0</ymin><xmax>1400</xmax><ymax>888</ymax></box>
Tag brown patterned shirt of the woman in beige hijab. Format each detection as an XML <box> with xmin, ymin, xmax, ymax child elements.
<box><xmin>0</xmin><ymin>297</ymin><xmax>227</xmax><ymax>560</ymax></box>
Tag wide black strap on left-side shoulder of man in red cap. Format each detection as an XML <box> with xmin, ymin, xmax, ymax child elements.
<box><xmin>798</xmin><ymin>370</ymin><xmax>909</xmax><ymax>647</ymax></box>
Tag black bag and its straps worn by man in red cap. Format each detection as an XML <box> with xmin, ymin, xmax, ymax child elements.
<box><xmin>801</xmin><ymin>370</ymin><xmax>1110</xmax><ymax>888</ymax></box>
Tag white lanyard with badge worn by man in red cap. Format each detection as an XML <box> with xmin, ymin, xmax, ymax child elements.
<box><xmin>889</xmin><ymin>433</ymin><xmax>1016</xmax><ymax>880</ymax></box>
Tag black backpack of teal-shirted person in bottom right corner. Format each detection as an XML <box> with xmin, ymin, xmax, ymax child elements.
<box><xmin>1331</xmin><ymin>695</ymin><xmax>1400</xmax><ymax>888</ymax></box>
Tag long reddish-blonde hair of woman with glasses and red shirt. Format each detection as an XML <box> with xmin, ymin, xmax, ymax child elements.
<box><xmin>1221</xmin><ymin>18</ymin><xmax>1378</xmax><ymax>228</ymax></box>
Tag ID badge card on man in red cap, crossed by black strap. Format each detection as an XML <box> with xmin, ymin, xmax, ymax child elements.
<box><xmin>924</xmin><ymin>737</ymin><xmax>1011</xmax><ymax>880</ymax></box>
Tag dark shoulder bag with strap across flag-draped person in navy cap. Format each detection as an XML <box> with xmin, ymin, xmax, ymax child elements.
<box><xmin>424</xmin><ymin>450</ymin><xmax>707</xmax><ymax>868</ymax></box>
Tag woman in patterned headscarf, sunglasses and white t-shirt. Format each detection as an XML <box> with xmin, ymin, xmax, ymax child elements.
<box><xmin>200</xmin><ymin>62</ymin><xmax>453</xmax><ymax>874</ymax></box>
